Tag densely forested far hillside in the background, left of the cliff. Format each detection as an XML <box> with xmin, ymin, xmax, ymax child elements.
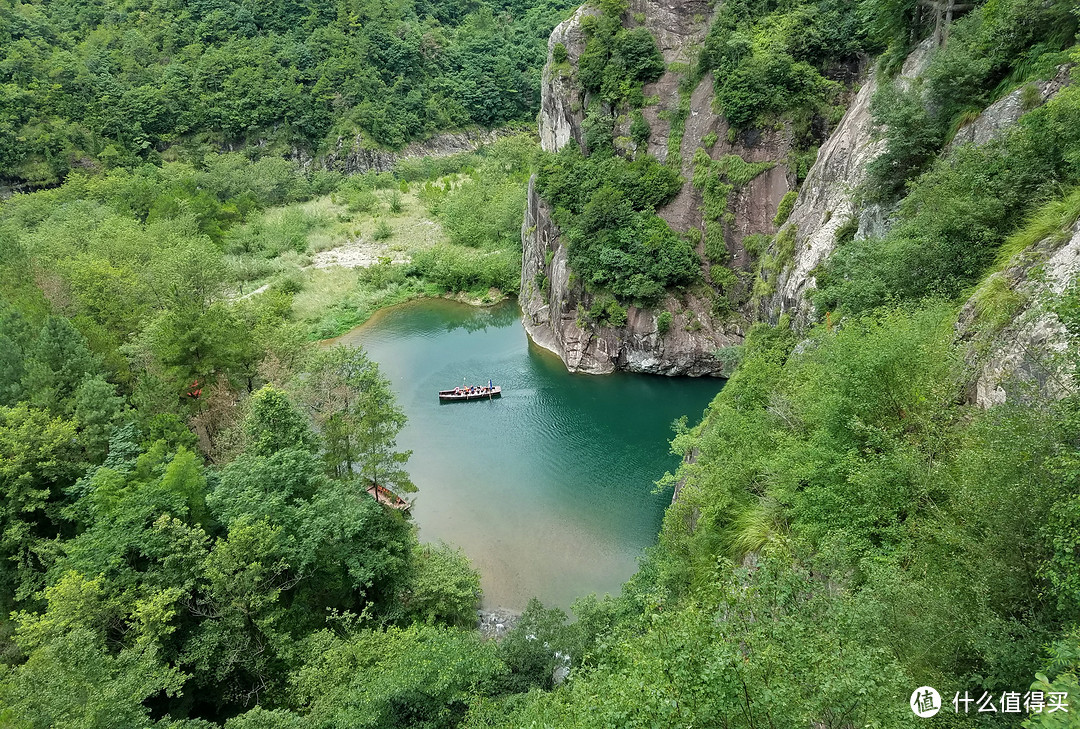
<box><xmin>0</xmin><ymin>0</ymin><xmax>576</xmax><ymax>185</ymax></box>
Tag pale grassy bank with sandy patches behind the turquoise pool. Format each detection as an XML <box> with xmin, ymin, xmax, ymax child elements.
<box><xmin>226</xmin><ymin>136</ymin><xmax>532</xmax><ymax>339</ymax></box>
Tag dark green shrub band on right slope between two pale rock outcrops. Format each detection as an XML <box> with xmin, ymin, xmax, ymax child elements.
<box><xmin>813</xmin><ymin>87</ymin><xmax>1080</xmax><ymax>311</ymax></box>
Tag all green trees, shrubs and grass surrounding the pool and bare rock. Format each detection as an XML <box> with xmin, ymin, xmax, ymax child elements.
<box><xmin>0</xmin><ymin>0</ymin><xmax>1080</xmax><ymax>729</ymax></box>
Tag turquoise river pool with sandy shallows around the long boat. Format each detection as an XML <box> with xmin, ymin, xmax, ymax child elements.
<box><xmin>338</xmin><ymin>299</ymin><xmax>723</xmax><ymax>609</ymax></box>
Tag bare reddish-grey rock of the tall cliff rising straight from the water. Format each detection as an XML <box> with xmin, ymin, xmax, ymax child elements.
<box><xmin>521</xmin><ymin>0</ymin><xmax>795</xmax><ymax>376</ymax></box>
